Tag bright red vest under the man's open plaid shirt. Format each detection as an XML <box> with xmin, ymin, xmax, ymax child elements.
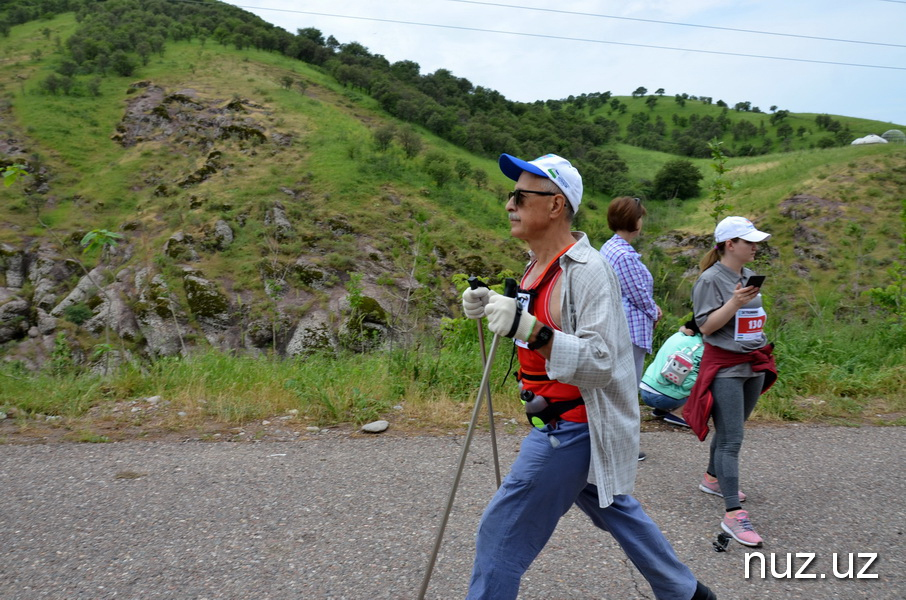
<box><xmin>516</xmin><ymin>246</ymin><xmax>588</xmax><ymax>423</ymax></box>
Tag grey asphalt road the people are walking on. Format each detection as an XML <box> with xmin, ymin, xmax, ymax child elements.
<box><xmin>0</xmin><ymin>426</ymin><xmax>906</xmax><ymax>600</ymax></box>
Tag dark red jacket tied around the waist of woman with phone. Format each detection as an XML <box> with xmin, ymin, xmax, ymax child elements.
<box><xmin>683</xmin><ymin>342</ymin><xmax>777</xmax><ymax>441</ymax></box>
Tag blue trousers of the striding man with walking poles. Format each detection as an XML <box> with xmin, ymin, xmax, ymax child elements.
<box><xmin>467</xmin><ymin>421</ymin><xmax>696</xmax><ymax>600</ymax></box>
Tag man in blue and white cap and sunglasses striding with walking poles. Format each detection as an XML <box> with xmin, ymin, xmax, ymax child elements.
<box><xmin>463</xmin><ymin>154</ymin><xmax>716</xmax><ymax>600</ymax></box>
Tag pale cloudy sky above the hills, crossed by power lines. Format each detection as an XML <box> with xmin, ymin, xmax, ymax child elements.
<box><xmin>224</xmin><ymin>0</ymin><xmax>906</xmax><ymax>127</ymax></box>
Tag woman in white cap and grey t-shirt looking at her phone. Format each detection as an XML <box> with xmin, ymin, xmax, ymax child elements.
<box><xmin>683</xmin><ymin>217</ymin><xmax>777</xmax><ymax>546</ymax></box>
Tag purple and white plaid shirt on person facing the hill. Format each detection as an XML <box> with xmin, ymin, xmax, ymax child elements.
<box><xmin>601</xmin><ymin>234</ymin><xmax>657</xmax><ymax>353</ymax></box>
